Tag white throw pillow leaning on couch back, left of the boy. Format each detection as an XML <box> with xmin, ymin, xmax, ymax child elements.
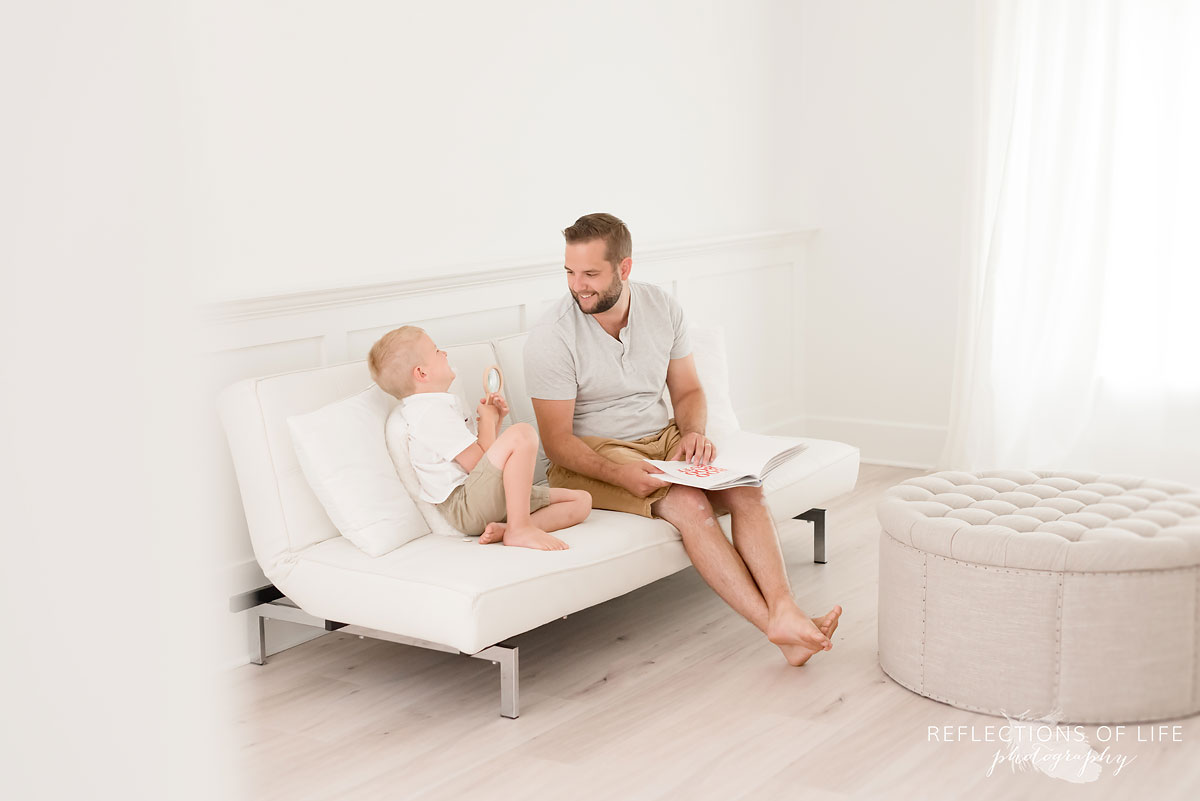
<box><xmin>288</xmin><ymin>384</ymin><xmax>430</xmax><ymax>556</ymax></box>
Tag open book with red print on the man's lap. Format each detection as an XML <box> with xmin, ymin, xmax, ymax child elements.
<box><xmin>647</xmin><ymin>432</ymin><xmax>808</xmax><ymax>489</ymax></box>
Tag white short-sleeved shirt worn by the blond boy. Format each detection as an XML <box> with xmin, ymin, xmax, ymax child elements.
<box><xmin>402</xmin><ymin>392</ymin><xmax>476</xmax><ymax>504</ymax></box>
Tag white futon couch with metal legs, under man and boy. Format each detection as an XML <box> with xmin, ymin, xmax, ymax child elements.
<box><xmin>218</xmin><ymin>329</ymin><xmax>859</xmax><ymax>717</ymax></box>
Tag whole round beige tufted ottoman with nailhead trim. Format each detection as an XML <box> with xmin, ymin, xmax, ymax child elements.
<box><xmin>878</xmin><ymin>470</ymin><xmax>1200</xmax><ymax>723</ymax></box>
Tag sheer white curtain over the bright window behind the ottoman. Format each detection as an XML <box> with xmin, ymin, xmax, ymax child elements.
<box><xmin>942</xmin><ymin>0</ymin><xmax>1200</xmax><ymax>486</ymax></box>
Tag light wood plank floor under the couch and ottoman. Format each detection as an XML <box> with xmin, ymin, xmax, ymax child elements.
<box><xmin>229</xmin><ymin>465</ymin><xmax>1200</xmax><ymax>801</ymax></box>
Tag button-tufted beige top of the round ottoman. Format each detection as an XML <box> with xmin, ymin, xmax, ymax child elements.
<box><xmin>878</xmin><ymin>470</ymin><xmax>1200</xmax><ymax>572</ymax></box>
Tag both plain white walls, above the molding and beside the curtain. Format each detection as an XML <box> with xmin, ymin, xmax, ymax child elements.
<box><xmin>185</xmin><ymin>0</ymin><xmax>976</xmax><ymax>465</ymax></box>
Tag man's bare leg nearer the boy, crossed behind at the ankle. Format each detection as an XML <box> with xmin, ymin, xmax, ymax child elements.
<box><xmin>653</xmin><ymin>486</ymin><xmax>841</xmax><ymax>663</ymax></box>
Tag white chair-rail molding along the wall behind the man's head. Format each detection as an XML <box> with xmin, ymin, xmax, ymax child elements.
<box><xmin>200</xmin><ymin>228</ymin><xmax>816</xmax><ymax>323</ymax></box>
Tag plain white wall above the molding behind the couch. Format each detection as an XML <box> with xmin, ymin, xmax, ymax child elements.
<box><xmin>186</xmin><ymin>0</ymin><xmax>798</xmax><ymax>300</ymax></box>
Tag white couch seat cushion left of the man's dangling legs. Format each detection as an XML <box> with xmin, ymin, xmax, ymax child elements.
<box><xmin>280</xmin><ymin>511</ymin><xmax>690</xmax><ymax>654</ymax></box>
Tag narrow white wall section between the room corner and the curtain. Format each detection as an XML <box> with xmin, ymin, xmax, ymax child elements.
<box><xmin>784</xmin><ymin>0</ymin><xmax>976</xmax><ymax>465</ymax></box>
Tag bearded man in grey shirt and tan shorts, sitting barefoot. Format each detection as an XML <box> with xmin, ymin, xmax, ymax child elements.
<box><xmin>524</xmin><ymin>213</ymin><xmax>841</xmax><ymax>666</ymax></box>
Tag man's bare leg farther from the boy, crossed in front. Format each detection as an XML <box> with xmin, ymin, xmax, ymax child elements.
<box><xmin>712</xmin><ymin>487</ymin><xmax>841</xmax><ymax>661</ymax></box>
